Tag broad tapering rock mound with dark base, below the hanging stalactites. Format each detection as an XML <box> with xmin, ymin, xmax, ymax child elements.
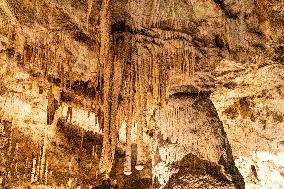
<box><xmin>153</xmin><ymin>92</ymin><xmax>244</xmax><ymax>188</ymax></box>
